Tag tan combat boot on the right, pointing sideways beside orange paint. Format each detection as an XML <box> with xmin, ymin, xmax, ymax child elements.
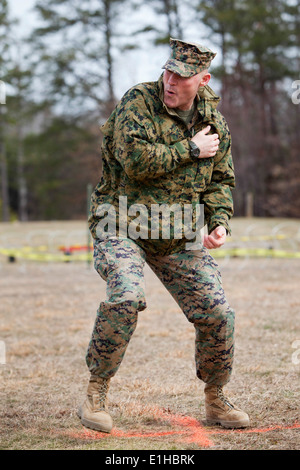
<box><xmin>204</xmin><ymin>384</ymin><xmax>250</xmax><ymax>428</ymax></box>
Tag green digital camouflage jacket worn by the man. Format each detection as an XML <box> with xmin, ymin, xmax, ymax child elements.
<box><xmin>89</xmin><ymin>76</ymin><xmax>234</xmax><ymax>255</ymax></box>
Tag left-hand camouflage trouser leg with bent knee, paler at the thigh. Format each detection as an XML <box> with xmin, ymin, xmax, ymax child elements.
<box><xmin>86</xmin><ymin>239</ymin><xmax>146</xmax><ymax>378</ymax></box>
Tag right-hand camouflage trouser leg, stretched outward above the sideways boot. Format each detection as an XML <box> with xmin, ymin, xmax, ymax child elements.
<box><xmin>147</xmin><ymin>248</ymin><xmax>234</xmax><ymax>385</ymax></box>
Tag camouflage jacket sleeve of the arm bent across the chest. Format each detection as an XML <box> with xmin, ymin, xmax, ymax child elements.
<box><xmin>109</xmin><ymin>89</ymin><xmax>191</xmax><ymax>181</ymax></box>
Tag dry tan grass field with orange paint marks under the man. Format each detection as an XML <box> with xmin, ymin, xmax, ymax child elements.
<box><xmin>0</xmin><ymin>220</ymin><xmax>300</xmax><ymax>450</ymax></box>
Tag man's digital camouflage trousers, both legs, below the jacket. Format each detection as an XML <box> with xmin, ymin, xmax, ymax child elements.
<box><xmin>86</xmin><ymin>238</ymin><xmax>234</xmax><ymax>385</ymax></box>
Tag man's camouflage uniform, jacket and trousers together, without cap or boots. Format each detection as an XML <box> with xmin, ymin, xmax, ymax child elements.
<box><xmin>86</xmin><ymin>60</ymin><xmax>234</xmax><ymax>385</ymax></box>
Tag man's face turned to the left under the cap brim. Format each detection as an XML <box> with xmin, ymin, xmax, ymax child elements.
<box><xmin>163</xmin><ymin>70</ymin><xmax>210</xmax><ymax>111</ymax></box>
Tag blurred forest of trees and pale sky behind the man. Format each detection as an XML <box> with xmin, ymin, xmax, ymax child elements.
<box><xmin>0</xmin><ymin>0</ymin><xmax>300</xmax><ymax>221</ymax></box>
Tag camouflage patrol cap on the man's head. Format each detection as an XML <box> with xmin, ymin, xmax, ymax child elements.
<box><xmin>162</xmin><ymin>38</ymin><xmax>216</xmax><ymax>77</ymax></box>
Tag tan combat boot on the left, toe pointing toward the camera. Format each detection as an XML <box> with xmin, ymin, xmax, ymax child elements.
<box><xmin>78</xmin><ymin>375</ymin><xmax>113</xmax><ymax>432</ymax></box>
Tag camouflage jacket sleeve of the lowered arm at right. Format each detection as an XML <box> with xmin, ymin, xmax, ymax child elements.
<box><xmin>201</xmin><ymin>126</ymin><xmax>235</xmax><ymax>234</ymax></box>
